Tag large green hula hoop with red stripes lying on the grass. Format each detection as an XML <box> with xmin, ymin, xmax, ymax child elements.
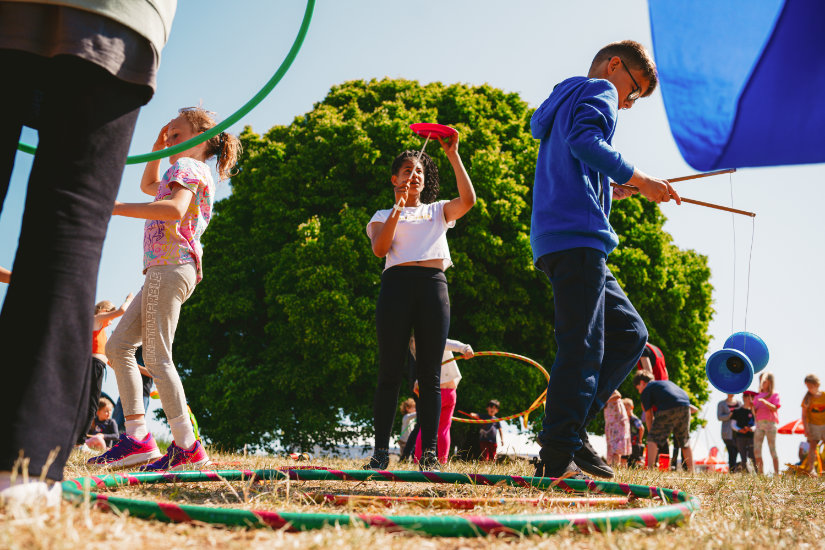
<box><xmin>63</xmin><ymin>469</ymin><xmax>699</xmax><ymax>537</ymax></box>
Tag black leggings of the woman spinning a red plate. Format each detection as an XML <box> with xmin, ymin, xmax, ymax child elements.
<box><xmin>373</xmin><ymin>266</ymin><xmax>450</xmax><ymax>458</ymax></box>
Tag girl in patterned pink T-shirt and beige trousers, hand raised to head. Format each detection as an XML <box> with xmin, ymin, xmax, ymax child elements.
<box><xmin>89</xmin><ymin>108</ymin><xmax>240</xmax><ymax>471</ymax></box>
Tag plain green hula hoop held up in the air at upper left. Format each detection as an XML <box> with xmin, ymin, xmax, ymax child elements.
<box><xmin>17</xmin><ymin>0</ymin><xmax>315</xmax><ymax>164</ymax></box>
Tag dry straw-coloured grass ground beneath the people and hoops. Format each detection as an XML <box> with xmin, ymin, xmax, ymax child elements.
<box><xmin>0</xmin><ymin>451</ymin><xmax>825</xmax><ymax>550</ymax></box>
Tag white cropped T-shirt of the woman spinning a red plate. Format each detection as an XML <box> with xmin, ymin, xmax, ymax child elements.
<box><xmin>367</xmin><ymin>201</ymin><xmax>455</xmax><ymax>270</ymax></box>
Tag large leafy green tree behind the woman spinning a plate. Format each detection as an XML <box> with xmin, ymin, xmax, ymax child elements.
<box><xmin>175</xmin><ymin>79</ymin><xmax>711</xmax><ymax>448</ymax></box>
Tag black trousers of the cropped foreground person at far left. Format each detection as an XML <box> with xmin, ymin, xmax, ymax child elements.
<box><xmin>0</xmin><ymin>49</ymin><xmax>151</xmax><ymax>481</ymax></box>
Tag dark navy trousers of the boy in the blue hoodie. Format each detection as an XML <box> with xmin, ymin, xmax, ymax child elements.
<box><xmin>537</xmin><ymin>248</ymin><xmax>647</xmax><ymax>456</ymax></box>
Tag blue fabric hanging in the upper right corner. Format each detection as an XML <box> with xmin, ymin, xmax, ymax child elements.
<box><xmin>649</xmin><ymin>0</ymin><xmax>825</xmax><ymax>171</ymax></box>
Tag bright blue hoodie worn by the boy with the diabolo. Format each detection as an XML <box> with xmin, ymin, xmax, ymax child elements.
<box><xmin>530</xmin><ymin>76</ymin><xmax>633</xmax><ymax>263</ymax></box>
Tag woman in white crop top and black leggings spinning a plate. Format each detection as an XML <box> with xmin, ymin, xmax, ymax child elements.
<box><xmin>365</xmin><ymin>134</ymin><xmax>476</xmax><ymax>469</ymax></box>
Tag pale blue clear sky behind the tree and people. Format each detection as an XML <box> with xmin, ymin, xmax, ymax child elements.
<box><xmin>0</xmin><ymin>0</ymin><xmax>825</xmax><ymax>468</ymax></box>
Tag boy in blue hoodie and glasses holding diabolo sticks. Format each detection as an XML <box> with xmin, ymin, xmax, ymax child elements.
<box><xmin>530</xmin><ymin>40</ymin><xmax>680</xmax><ymax>478</ymax></box>
